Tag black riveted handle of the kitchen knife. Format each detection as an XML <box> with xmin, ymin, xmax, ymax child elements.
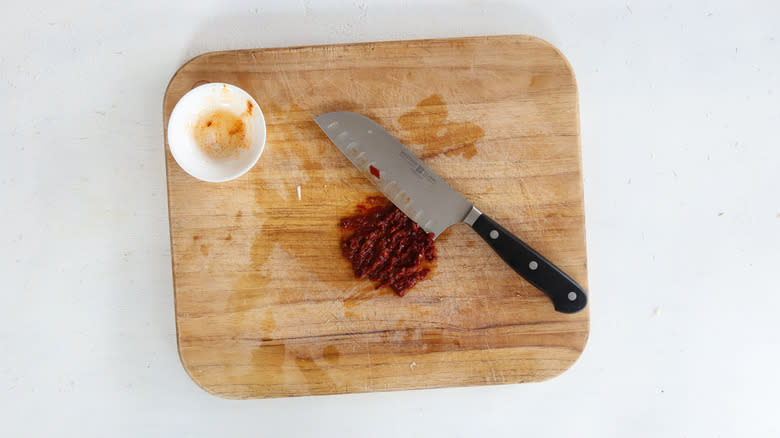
<box><xmin>471</xmin><ymin>213</ymin><xmax>588</xmax><ymax>313</ymax></box>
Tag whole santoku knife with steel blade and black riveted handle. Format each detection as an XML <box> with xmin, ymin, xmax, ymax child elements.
<box><xmin>314</xmin><ymin>111</ymin><xmax>588</xmax><ymax>313</ymax></box>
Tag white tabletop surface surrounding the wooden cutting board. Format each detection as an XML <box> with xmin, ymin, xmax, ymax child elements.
<box><xmin>0</xmin><ymin>0</ymin><xmax>780</xmax><ymax>437</ymax></box>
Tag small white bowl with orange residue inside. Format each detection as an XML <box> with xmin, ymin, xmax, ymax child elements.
<box><xmin>168</xmin><ymin>83</ymin><xmax>265</xmax><ymax>182</ymax></box>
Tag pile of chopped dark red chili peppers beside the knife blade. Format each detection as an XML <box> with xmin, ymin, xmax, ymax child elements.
<box><xmin>341</xmin><ymin>196</ymin><xmax>436</xmax><ymax>296</ymax></box>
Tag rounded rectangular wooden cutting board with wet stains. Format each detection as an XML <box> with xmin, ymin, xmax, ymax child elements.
<box><xmin>164</xmin><ymin>36</ymin><xmax>589</xmax><ymax>398</ymax></box>
